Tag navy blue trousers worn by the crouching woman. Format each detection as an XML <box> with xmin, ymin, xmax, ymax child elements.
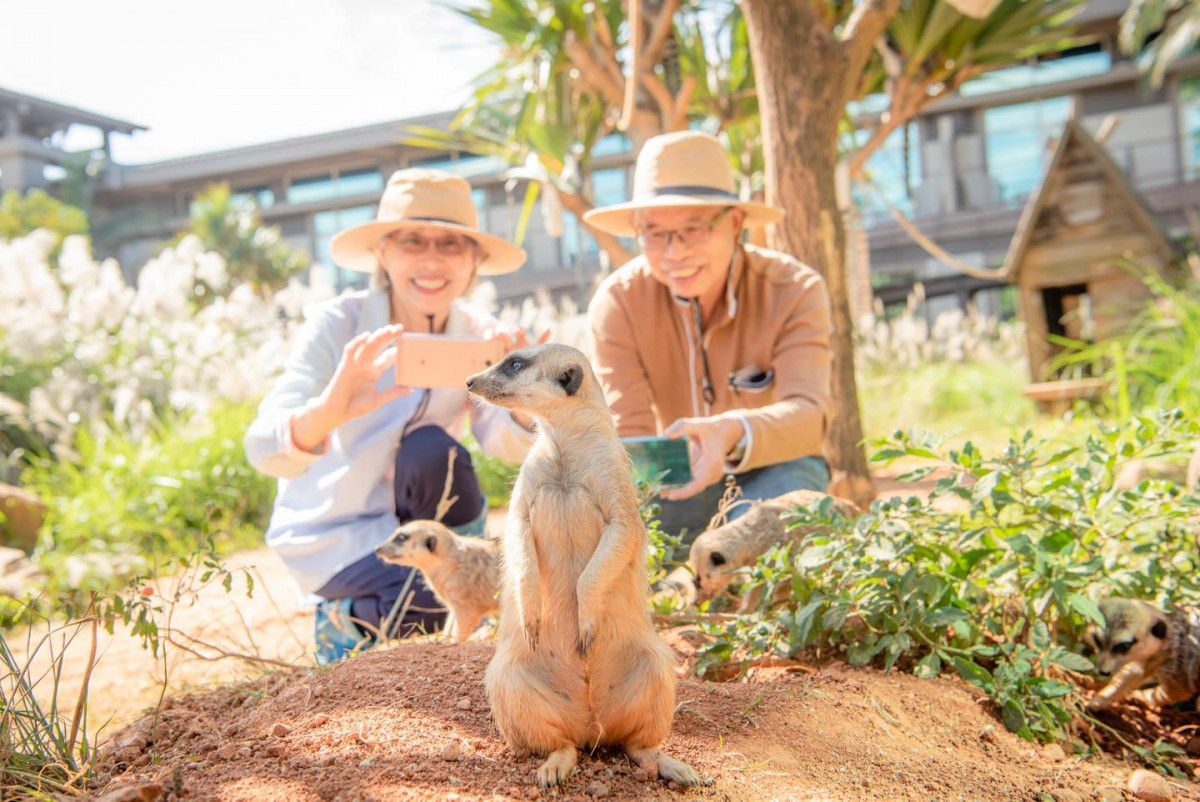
<box><xmin>317</xmin><ymin>426</ymin><xmax>484</xmax><ymax>636</ymax></box>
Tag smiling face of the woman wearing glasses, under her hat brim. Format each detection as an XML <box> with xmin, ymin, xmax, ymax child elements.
<box><xmin>379</xmin><ymin>226</ymin><xmax>479</xmax><ymax>321</ymax></box>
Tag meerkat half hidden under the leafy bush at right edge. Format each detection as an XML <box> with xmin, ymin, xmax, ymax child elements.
<box><xmin>1087</xmin><ymin>598</ymin><xmax>1200</xmax><ymax>711</ymax></box>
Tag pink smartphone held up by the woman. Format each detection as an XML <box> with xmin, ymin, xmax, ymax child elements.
<box><xmin>396</xmin><ymin>334</ymin><xmax>504</xmax><ymax>390</ymax></box>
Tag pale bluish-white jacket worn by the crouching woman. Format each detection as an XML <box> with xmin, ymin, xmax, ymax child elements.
<box><xmin>245</xmin><ymin>291</ymin><xmax>534</xmax><ymax>592</ymax></box>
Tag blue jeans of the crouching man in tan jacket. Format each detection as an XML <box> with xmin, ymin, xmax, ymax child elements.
<box><xmin>658</xmin><ymin>456</ymin><xmax>829</xmax><ymax>546</ymax></box>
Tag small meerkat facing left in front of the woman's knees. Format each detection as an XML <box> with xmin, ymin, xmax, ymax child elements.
<box><xmin>376</xmin><ymin>521</ymin><xmax>500</xmax><ymax>644</ymax></box>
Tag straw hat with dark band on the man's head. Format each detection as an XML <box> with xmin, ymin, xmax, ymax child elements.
<box><xmin>583</xmin><ymin>131</ymin><xmax>784</xmax><ymax>237</ymax></box>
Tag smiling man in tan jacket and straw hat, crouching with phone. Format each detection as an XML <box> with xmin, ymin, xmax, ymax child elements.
<box><xmin>584</xmin><ymin>131</ymin><xmax>832</xmax><ymax>541</ymax></box>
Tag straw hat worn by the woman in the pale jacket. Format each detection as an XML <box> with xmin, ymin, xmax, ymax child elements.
<box><xmin>330</xmin><ymin>168</ymin><xmax>526</xmax><ymax>276</ymax></box>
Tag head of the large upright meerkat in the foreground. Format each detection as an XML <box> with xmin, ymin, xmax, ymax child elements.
<box><xmin>467</xmin><ymin>343</ymin><xmax>608</xmax><ymax>419</ymax></box>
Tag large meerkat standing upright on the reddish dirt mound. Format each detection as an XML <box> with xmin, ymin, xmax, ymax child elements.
<box><xmin>467</xmin><ymin>345</ymin><xmax>700</xmax><ymax>788</ymax></box>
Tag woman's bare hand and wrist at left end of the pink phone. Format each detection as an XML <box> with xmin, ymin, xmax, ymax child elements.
<box><xmin>292</xmin><ymin>324</ymin><xmax>413</xmax><ymax>451</ymax></box>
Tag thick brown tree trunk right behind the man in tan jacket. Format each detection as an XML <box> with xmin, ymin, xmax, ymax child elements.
<box><xmin>743</xmin><ymin>0</ymin><xmax>875</xmax><ymax>507</ymax></box>
